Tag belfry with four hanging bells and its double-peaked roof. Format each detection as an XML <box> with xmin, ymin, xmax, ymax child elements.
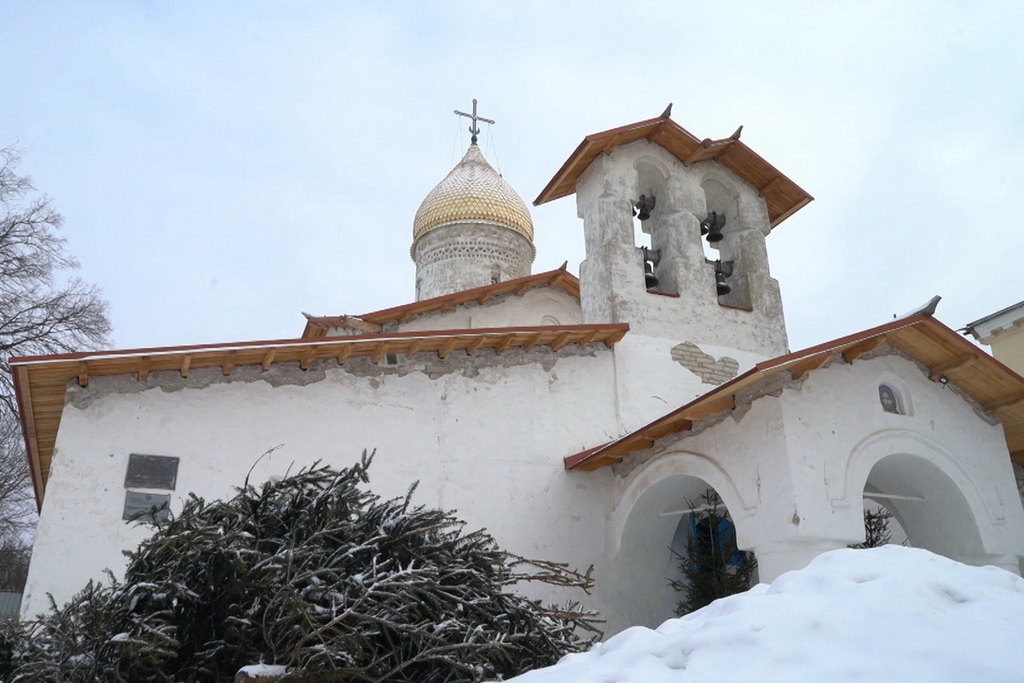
<box><xmin>535</xmin><ymin>112</ymin><xmax>812</xmax><ymax>356</ymax></box>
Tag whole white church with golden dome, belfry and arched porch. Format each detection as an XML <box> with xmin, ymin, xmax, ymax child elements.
<box><xmin>10</xmin><ymin>108</ymin><xmax>1024</xmax><ymax>635</ymax></box>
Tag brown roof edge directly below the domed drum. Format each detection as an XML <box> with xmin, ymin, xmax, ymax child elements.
<box><xmin>302</xmin><ymin>265</ymin><xmax>580</xmax><ymax>339</ymax></box>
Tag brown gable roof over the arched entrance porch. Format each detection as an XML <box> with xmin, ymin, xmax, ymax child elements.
<box><xmin>564</xmin><ymin>315</ymin><xmax>1024</xmax><ymax>471</ymax></box>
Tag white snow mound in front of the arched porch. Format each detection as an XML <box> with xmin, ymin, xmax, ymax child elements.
<box><xmin>512</xmin><ymin>546</ymin><xmax>1024</xmax><ymax>683</ymax></box>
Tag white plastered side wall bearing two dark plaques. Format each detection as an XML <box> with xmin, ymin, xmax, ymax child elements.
<box><xmin>23</xmin><ymin>345</ymin><xmax>617</xmax><ymax>616</ymax></box>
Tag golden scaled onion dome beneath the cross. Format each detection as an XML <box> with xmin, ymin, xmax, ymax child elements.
<box><xmin>413</xmin><ymin>144</ymin><xmax>534</xmax><ymax>243</ymax></box>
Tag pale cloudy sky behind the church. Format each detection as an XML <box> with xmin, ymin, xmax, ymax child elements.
<box><xmin>0</xmin><ymin>5</ymin><xmax>1024</xmax><ymax>356</ymax></box>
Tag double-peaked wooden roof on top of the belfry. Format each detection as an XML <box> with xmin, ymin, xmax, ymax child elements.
<box><xmin>534</xmin><ymin>117</ymin><xmax>814</xmax><ymax>227</ymax></box>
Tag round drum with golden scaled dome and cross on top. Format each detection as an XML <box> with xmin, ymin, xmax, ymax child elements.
<box><xmin>411</xmin><ymin>99</ymin><xmax>537</xmax><ymax>301</ymax></box>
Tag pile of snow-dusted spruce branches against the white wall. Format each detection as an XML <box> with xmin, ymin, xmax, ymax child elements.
<box><xmin>6</xmin><ymin>455</ymin><xmax>593</xmax><ymax>682</ymax></box>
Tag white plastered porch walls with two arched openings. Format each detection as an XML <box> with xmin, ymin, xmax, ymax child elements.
<box><xmin>605</xmin><ymin>354</ymin><xmax>1024</xmax><ymax>630</ymax></box>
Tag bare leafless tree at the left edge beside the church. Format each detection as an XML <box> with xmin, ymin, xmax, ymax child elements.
<box><xmin>0</xmin><ymin>146</ymin><xmax>111</xmax><ymax>581</ymax></box>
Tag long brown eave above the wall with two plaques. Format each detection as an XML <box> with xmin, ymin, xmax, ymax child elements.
<box><xmin>10</xmin><ymin>324</ymin><xmax>629</xmax><ymax>505</ymax></box>
